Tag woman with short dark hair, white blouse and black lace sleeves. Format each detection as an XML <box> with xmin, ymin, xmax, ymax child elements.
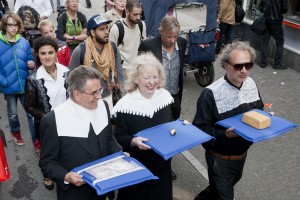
<box><xmin>25</xmin><ymin>37</ymin><xmax>69</xmax><ymax>190</ymax></box>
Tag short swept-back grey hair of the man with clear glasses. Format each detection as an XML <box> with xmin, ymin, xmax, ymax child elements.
<box><xmin>68</xmin><ymin>65</ymin><xmax>101</xmax><ymax>99</ymax></box>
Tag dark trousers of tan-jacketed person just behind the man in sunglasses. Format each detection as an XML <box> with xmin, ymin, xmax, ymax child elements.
<box><xmin>216</xmin><ymin>22</ymin><xmax>235</xmax><ymax>53</ymax></box>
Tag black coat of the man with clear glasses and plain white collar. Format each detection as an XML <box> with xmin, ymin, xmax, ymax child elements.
<box><xmin>39</xmin><ymin>105</ymin><xmax>121</xmax><ymax>200</ymax></box>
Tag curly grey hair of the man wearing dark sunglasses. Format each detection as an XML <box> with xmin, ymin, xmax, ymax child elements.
<box><xmin>221</xmin><ymin>41</ymin><xmax>256</xmax><ymax>68</ymax></box>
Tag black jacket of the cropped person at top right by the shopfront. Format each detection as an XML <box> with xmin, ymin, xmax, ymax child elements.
<box><xmin>260</xmin><ymin>0</ymin><xmax>288</xmax><ymax>21</ymax></box>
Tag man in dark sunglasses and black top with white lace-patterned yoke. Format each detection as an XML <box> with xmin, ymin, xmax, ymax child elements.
<box><xmin>193</xmin><ymin>41</ymin><xmax>264</xmax><ymax>200</ymax></box>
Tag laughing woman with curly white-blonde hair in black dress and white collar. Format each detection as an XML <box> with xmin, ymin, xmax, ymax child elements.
<box><xmin>112</xmin><ymin>53</ymin><xmax>173</xmax><ymax>200</ymax></box>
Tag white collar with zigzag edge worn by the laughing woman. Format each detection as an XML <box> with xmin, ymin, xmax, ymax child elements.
<box><xmin>112</xmin><ymin>88</ymin><xmax>174</xmax><ymax>118</ymax></box>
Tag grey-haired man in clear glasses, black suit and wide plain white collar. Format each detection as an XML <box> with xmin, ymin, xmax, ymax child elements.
<box><xmin>39</xmin><ymin>66</ymin><xmax>121</xmax><ymax>200</ymax></box>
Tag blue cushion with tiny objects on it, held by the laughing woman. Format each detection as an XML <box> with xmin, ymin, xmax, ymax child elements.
<box><xmin>134</xmin><ymin>119</ymin><xmax>212</xmax><ymax>160</ymax></box>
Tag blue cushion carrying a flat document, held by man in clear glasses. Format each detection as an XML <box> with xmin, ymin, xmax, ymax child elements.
<box><xmin>72</xmin><ymin>152</ymin><xmax>158</xmax><ymax>195</ymax></box>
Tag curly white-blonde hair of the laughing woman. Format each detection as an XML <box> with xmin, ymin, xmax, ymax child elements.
<box><xmin>125</xmin><ymin>52</ymin><xmax>165</xmax><ymax>92</ymax></box>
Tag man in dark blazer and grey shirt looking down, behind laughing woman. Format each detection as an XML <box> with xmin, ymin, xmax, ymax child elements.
<box><xmin>139</xmin><ymin>16</ymin><xmax>187</xmax><ymax>180</ymax></box>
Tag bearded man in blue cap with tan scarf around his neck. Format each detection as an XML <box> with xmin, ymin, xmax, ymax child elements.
<box><xmin>70</xmin><ymin>15</ymin><xmax>124</xmax><ymax>110</ymax></box>
